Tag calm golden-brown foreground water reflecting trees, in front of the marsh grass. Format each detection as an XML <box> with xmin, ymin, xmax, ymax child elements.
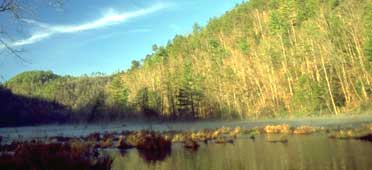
<box><xmin>109</xmin><ymin>135</ymin><xmax>372</xmax><ymax>170</ymax></box>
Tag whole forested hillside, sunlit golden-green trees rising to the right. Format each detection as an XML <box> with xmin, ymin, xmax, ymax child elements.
<box><xmin>0</xmin><ymin>0</ymin><xmax>372</xmax><ymax>123</ymax></box>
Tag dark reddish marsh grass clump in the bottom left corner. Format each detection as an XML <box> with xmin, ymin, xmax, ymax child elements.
<box><xmin>0</xmin><ymin>143</ymin><xmax>112</xmax><ymax>170</ymax></box>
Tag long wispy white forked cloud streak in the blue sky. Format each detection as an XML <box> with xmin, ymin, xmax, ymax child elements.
<box><xmin>0</xmin><ymin>3</ymin><xmax>168</xmax><ymax>48</ymax></box>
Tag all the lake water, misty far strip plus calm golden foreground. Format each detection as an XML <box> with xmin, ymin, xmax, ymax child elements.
<box><xmin>0</xmin><ymin>116</ymin><xmax>372</xmax><ymax>170</ymax></box>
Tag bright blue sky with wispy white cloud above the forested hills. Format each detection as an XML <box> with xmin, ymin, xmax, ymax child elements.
<box><xmin>0</xmin><ymin>0</ymin><xmax>243</xmax><ymax>81</ymax></box>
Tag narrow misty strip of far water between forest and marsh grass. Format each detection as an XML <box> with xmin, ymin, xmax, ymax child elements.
<box><xmin>0</xmin><ymin>115</ymin><xmax>372</xmax><ymax>143</ymax></box>
